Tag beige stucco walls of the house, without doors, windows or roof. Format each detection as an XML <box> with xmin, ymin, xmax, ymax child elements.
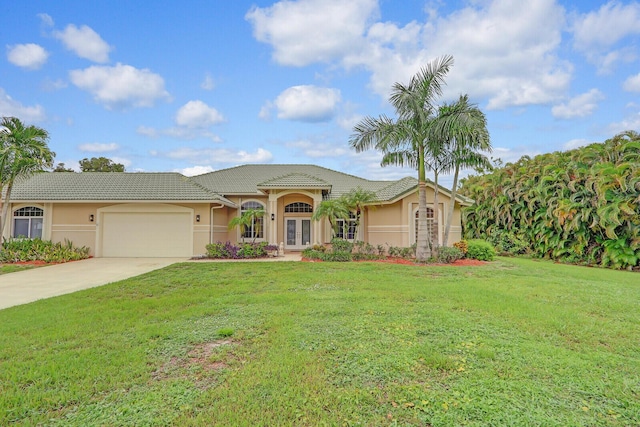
<box><xmin>5</xmin><ymin>184</ymin><xmax>461</xmax><ymax>256</ymax></box>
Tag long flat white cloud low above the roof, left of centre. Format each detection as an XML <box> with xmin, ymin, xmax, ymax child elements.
<box><xmin>164</xmin><ymin>147</ymin><xmax>273</xmax><ymax>165</ymax></box>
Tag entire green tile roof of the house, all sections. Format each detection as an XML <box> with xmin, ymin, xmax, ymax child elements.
<box><xmin>6</xmin><ymin>164</ymin><xmax>473</xmax><ymax>206</ymax></box>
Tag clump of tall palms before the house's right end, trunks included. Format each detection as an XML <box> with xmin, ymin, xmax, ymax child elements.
<box><xmin>350</xmin><ymin>56</ymin><xmax>491</xmax><ymax>261</ymax></box>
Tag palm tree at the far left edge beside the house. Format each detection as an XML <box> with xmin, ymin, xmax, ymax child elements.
<box><xmin>0</xmin><ymin>117</ymin><xmax>55</xmax><ymax>241</ymax></box>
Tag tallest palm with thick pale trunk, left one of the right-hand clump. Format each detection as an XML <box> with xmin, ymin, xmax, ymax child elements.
<box><xmin>349</xmin><ymin>55</ymin><xmax>453</xmax><ymax>261</ymax></box>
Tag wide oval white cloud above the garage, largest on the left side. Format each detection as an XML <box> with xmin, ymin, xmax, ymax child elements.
<box><xmin>69</xmin><ymin>64</ymin><xmax>169</xmax><ymax>109</ymax></box>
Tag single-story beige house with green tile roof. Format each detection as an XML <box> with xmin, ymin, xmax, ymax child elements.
<box><xmin>3</xmin><ymin>164</ymin><xmax>470</xmax><ymax>257</ymax></box>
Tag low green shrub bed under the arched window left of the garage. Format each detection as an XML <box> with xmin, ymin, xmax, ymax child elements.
<box><xmin>0</xmin><ymin>238</ymin><xmax>89</xmax><ymax>263</ymax></box>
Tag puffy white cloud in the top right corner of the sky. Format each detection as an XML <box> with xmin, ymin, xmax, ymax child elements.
<box><xmin>572</xmin><ymin>1</ymin><xmax>640</xmax><ymax>73</ymax></box>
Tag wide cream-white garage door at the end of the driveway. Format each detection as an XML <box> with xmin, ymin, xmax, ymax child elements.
<box><xmin>101</xmin><ymin>212</ymin><xmax>193</xmax><ymax>257</ymax></box>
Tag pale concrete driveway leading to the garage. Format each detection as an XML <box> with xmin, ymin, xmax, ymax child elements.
<box><xmin>0</xmin><ymin>258</ymin><xmax>188</xmax><ymax>310</ymax></box>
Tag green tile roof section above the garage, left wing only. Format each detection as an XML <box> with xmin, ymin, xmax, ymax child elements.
<box><xmin>11</xmin><ymin>172</ymin><xmax>231</xmax><ymax>203</ymax></box>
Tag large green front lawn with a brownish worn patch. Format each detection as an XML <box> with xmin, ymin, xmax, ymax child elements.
<box><xmin>0</xmin><ymin>258</ymin><xmax>640</xmax><ymax>426</ymax></box>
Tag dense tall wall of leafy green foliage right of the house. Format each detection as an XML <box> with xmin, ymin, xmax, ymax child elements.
<box><xmin>461</xmin><ymin>131</ymin><xmax>640</xmax><ymax>269</ymax></box>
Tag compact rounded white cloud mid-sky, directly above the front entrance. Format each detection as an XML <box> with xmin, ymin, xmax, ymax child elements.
<box><xmin>268</xmin><ymin>85</ymin><xmax>341</xmax><ymax>122</ymax></box>
